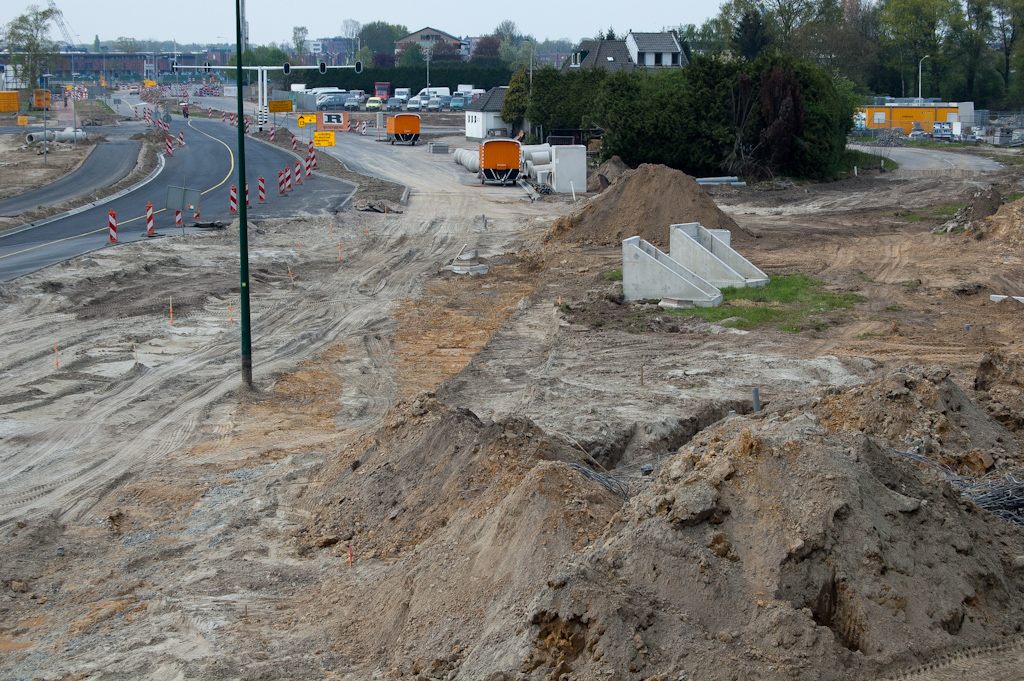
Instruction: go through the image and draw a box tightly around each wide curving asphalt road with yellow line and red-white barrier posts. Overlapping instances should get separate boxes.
[0,118,355,281]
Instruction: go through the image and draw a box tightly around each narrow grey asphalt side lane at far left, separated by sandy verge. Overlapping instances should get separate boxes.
[0,139,142,217]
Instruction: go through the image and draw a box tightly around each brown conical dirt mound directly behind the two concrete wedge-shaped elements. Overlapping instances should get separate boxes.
[549,164,750,249]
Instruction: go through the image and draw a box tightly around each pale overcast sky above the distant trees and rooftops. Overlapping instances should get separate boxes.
[0,0,721,44]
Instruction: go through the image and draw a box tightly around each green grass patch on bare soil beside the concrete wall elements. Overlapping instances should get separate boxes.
[668,274,864,333]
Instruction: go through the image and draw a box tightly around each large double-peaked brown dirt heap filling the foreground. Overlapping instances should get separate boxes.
[299,372,1024,681]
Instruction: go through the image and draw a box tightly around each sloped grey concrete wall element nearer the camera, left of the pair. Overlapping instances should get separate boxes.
[623,237,722,307]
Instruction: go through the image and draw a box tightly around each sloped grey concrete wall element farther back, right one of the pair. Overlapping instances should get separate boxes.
[669,222,768,288]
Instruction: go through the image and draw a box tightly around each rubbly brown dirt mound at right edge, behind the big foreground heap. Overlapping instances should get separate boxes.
[814,363,1021,475]
